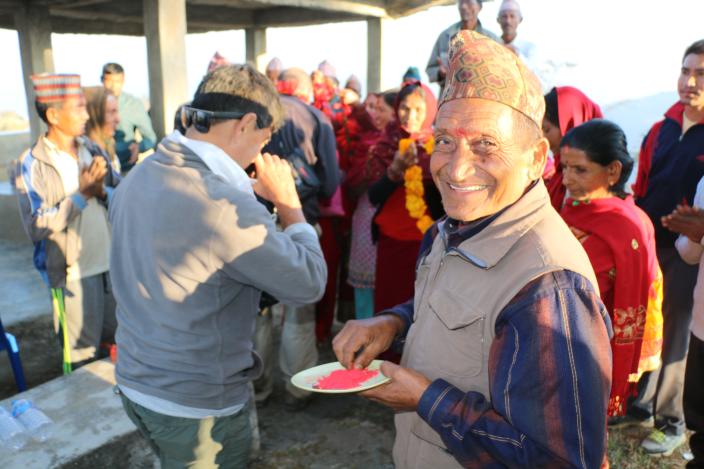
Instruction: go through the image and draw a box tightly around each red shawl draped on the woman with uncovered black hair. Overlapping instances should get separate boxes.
[561,196,660,415]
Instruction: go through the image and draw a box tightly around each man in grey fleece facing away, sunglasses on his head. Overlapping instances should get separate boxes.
[110,65,326,468]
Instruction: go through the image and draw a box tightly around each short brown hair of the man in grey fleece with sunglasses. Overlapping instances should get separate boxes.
[191,64,285,130]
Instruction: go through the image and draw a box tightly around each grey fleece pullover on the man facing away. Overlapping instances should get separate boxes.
[110,139,327,409]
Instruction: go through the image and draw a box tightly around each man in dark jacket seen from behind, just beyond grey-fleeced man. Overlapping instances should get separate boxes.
[255,68,340,409]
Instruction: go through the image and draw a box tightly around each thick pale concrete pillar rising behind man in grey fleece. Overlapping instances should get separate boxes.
[143,0,188,139]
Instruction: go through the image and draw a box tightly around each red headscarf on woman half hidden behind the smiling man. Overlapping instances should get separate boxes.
[546,86,604,212]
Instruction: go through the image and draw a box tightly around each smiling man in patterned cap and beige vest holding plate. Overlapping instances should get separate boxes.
[334,31,611,468]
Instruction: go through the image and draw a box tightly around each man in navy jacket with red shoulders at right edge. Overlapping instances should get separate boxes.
[619,41,704,454]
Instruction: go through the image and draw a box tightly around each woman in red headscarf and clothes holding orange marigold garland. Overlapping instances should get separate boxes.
[368,81,442,311]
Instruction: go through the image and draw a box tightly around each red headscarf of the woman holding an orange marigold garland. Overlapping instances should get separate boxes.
[367,81,438,182]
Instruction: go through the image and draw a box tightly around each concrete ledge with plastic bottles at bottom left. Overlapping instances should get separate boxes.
[0,360,144,469]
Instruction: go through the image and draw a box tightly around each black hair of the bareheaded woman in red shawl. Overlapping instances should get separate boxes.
[560,119,633,198]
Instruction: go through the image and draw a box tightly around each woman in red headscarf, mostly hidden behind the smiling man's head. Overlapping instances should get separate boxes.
[543,86,604,208]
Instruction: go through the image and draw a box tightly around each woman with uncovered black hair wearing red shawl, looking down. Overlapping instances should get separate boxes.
[560,119,662,417]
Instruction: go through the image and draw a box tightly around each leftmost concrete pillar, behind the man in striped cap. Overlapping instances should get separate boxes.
[15,2,54,142]
